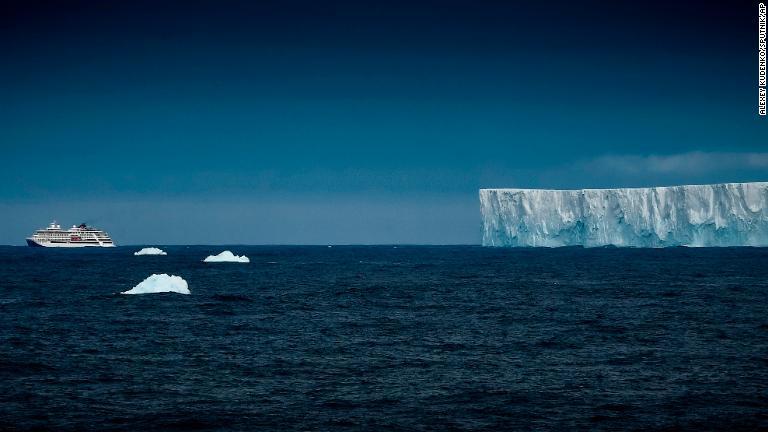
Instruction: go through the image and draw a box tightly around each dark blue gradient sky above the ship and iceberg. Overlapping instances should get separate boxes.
[0,1,768,244]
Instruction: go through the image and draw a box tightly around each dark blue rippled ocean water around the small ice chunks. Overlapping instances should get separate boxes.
[0,246,768,431]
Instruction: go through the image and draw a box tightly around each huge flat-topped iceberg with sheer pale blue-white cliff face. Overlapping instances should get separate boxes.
[480,183,768,247]
